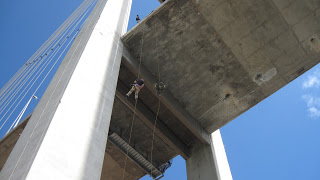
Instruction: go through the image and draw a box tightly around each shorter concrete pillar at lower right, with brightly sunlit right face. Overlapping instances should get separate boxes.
[186,130,232,180]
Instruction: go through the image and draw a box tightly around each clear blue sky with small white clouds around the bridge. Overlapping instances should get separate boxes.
[0,0,320,180]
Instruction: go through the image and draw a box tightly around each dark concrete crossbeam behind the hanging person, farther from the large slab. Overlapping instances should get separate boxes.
[116,80,190,159]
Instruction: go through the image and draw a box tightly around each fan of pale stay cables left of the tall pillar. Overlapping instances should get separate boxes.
[0,0,96,136]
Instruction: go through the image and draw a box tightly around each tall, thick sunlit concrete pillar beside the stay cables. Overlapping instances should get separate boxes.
[0,0,131,180]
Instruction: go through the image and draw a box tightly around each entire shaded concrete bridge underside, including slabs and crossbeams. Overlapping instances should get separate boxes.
[0,0,320,179]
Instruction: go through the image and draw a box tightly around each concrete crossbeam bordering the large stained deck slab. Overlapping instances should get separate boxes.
[122,47,210,144]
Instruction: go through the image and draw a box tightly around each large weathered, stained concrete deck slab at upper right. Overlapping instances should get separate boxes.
[122,0,320,133]
